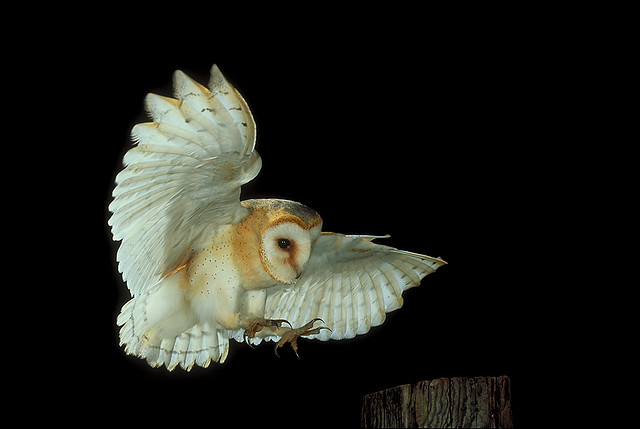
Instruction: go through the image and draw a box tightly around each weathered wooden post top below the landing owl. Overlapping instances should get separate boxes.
[361,376,513,428]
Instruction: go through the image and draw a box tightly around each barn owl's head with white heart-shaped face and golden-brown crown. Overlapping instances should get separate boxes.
[242,199,322,284]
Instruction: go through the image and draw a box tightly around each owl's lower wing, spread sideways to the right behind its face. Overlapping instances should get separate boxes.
[265,233,446,340]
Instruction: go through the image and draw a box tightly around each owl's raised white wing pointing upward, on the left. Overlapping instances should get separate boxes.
[109,65,262,296]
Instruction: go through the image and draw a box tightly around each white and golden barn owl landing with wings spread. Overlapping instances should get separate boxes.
[108,65,446,370]
